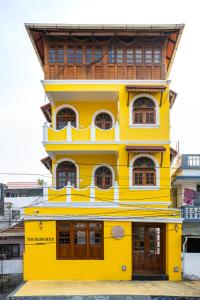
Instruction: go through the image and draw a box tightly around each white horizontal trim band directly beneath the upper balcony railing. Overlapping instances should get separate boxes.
[43,140,171,145]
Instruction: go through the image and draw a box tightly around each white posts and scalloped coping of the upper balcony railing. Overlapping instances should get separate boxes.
[43,121,120,143]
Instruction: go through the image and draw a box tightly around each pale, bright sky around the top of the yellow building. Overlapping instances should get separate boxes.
[0,0,200,183]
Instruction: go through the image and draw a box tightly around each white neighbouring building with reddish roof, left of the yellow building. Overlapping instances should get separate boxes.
[0,182,43,230]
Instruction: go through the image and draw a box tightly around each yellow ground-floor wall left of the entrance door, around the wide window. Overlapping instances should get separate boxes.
[24,221,132,280]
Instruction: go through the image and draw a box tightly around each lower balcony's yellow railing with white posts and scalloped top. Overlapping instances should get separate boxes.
[43,182,119,204]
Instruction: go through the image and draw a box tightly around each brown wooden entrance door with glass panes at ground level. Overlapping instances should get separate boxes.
[133,223,165,274]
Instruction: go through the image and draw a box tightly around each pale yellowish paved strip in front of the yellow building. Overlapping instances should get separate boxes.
[14,280,200,297]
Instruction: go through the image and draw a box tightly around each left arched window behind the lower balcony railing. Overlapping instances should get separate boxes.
[56,161,76,189]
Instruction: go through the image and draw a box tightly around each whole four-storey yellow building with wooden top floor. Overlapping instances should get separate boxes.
[24,24,184,280]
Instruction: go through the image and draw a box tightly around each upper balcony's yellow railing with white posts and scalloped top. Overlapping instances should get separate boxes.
[43,122,120,143]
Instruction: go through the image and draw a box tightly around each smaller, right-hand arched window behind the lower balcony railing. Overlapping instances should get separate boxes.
[94,166,112,189]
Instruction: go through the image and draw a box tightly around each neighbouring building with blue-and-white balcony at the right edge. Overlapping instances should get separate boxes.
[172,154,200,279]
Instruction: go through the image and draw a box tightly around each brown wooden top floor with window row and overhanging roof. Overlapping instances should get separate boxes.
[25,24,184,80]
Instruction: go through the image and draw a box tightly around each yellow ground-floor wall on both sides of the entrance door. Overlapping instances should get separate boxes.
[24,217,181,280]
